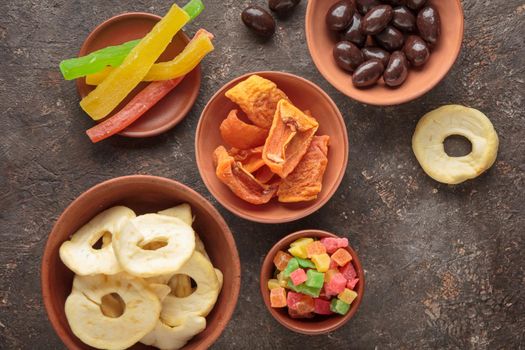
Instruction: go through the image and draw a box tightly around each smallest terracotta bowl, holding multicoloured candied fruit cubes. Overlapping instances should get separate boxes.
[260,230,365,335]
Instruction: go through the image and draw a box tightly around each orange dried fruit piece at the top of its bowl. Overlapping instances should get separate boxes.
[225,75,288,129]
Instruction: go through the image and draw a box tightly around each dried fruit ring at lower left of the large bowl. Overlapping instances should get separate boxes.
[65,273,161,349]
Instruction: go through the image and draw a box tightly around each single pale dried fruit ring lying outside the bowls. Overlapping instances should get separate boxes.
[412,105,499,184]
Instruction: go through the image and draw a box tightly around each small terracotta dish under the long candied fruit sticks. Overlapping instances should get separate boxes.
[77,12,201,137]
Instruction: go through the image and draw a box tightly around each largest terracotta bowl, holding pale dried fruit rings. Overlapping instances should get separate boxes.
[41,175,241,350]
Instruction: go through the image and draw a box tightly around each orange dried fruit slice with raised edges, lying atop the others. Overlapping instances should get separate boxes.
[263,100,319,179]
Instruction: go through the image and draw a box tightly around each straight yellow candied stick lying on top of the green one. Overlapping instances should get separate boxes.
[80,4,190,120]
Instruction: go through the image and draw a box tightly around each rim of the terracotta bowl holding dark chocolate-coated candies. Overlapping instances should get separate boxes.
[305,0,465,106]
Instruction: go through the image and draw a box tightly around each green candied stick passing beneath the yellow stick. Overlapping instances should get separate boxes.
[59,0,204,80]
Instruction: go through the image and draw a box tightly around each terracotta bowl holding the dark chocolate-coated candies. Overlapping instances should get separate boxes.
[306,0,464,106]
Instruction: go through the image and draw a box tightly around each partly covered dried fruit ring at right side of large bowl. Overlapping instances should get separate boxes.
[160,252,221,326]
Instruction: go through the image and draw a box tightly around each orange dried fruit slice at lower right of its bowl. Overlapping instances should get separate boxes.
[277,136,330,203]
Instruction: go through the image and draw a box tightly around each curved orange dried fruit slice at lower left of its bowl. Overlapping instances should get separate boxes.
[213,146,277,204]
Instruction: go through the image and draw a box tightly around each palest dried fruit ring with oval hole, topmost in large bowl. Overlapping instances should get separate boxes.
[113,214,195,277]
